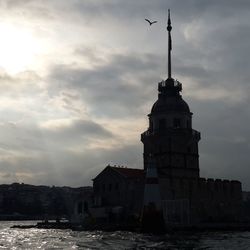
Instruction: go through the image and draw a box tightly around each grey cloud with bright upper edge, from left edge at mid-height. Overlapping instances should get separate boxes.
[0,119,115,153]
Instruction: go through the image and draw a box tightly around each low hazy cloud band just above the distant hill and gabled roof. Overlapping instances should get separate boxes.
[0,136,142,187]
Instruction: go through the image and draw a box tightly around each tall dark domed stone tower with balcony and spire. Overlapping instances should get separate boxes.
[141,9,200,178]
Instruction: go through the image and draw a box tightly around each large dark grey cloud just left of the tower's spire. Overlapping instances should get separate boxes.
[49,51,160,117]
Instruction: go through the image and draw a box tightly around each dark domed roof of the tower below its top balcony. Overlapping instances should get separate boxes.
[151,96,190,114]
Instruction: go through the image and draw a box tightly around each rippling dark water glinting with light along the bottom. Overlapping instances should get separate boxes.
[0,222,250,250]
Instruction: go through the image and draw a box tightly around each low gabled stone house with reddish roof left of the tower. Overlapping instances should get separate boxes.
[93,165,145,216]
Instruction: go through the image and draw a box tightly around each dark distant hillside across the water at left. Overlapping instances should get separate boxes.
[0,183,92,220]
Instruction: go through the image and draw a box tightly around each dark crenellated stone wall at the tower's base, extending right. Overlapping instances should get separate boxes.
[159,178,242,223]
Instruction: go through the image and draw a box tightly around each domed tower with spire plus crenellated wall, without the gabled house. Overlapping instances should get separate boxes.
[141,9,242,224]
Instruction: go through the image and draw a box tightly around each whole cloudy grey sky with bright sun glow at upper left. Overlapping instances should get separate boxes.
[0,0,250,190]
